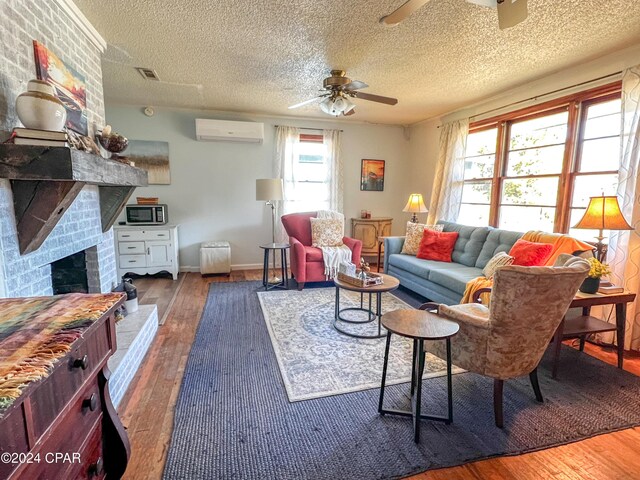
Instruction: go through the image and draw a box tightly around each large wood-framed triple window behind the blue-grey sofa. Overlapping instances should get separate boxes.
[458,83,621,240]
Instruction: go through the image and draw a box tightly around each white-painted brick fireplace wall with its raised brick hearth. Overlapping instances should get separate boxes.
[0,0,158,406]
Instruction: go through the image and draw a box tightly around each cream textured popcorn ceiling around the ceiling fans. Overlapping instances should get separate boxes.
[75,0,640,124]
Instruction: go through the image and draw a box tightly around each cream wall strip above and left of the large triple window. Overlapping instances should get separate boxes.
[409,45,640,207]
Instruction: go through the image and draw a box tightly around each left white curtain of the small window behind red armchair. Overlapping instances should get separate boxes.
[274,125,300,243]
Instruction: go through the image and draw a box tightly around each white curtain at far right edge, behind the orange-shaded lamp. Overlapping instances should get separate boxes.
[600,65,640,350]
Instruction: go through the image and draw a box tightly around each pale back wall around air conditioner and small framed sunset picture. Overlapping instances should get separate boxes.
[106,104,411,268]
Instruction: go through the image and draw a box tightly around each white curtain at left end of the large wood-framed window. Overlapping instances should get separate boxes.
[427,119,469,224]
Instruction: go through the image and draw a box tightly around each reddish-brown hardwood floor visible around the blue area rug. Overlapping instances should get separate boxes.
[119,270,640,480]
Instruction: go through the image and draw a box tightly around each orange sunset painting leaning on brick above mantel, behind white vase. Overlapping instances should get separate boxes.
[33,40,89,137]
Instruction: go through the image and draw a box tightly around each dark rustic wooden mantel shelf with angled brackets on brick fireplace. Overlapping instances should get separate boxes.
[0,144,148,254]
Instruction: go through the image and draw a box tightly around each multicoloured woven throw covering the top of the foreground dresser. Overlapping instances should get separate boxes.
[0,293,123,417]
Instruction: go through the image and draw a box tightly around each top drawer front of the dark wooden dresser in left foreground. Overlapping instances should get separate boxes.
[31,322,110,438]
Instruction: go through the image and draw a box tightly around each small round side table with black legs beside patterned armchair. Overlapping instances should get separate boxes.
[378,309,460,443]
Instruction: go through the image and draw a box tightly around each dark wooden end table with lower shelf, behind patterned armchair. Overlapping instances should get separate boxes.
[552,292,636,378]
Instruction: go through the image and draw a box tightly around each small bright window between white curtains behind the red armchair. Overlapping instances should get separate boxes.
[291,135,329,212]
